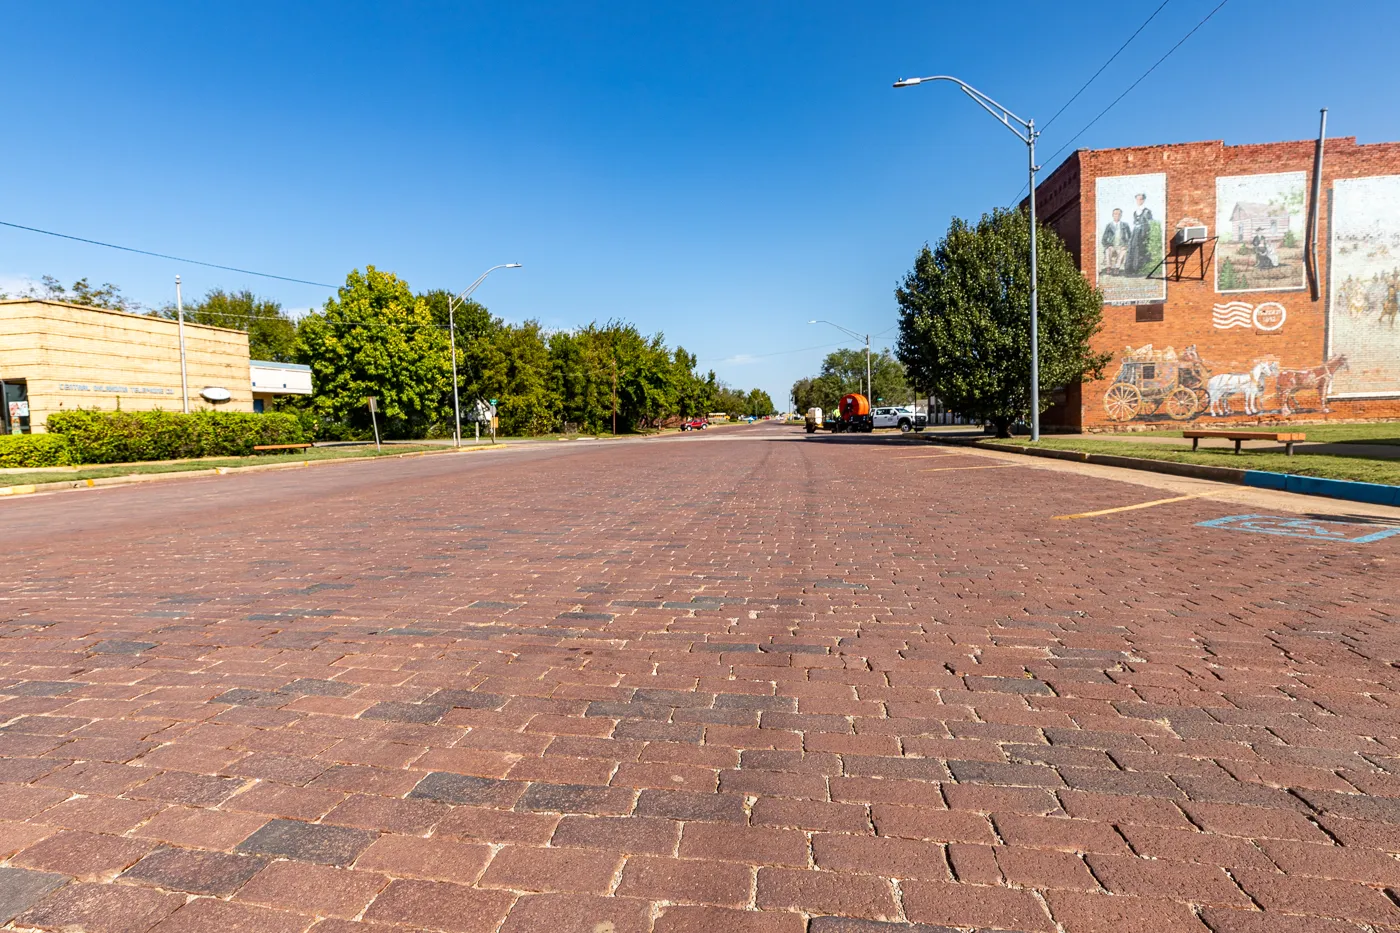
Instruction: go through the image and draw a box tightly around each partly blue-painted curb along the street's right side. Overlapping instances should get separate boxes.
[928,437,1400,506]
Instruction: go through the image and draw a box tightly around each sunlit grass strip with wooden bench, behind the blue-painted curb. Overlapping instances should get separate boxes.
[983,437,1400,486]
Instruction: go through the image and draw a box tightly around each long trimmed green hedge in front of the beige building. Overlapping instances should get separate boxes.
[48,409,304,464]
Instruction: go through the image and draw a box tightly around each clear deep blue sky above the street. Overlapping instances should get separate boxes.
[0,0,1400,406]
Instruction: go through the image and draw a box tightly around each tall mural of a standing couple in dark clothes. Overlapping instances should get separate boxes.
[1093,174,1166,304]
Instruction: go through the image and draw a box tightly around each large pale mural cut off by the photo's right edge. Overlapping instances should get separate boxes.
[1327,175,1400,396]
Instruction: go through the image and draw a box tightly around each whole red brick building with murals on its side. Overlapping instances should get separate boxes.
[1036,137,1400,430]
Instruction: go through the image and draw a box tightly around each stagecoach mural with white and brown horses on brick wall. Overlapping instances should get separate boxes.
[1103,343,1350,424]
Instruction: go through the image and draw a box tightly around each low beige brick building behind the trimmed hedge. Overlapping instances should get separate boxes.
[0,298,253,433]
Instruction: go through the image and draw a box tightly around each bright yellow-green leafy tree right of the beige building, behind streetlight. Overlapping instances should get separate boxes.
[297,266,452,437]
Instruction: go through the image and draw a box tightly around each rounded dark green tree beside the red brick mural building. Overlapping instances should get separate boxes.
[895,210,1112,437]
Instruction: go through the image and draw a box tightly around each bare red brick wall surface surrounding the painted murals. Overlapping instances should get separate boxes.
[1036,137,1400,430]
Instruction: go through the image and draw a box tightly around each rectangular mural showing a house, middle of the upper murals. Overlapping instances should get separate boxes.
[1215,172,1308,291]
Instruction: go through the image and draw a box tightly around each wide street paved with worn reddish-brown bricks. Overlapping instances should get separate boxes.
[0,427,1400,933]
